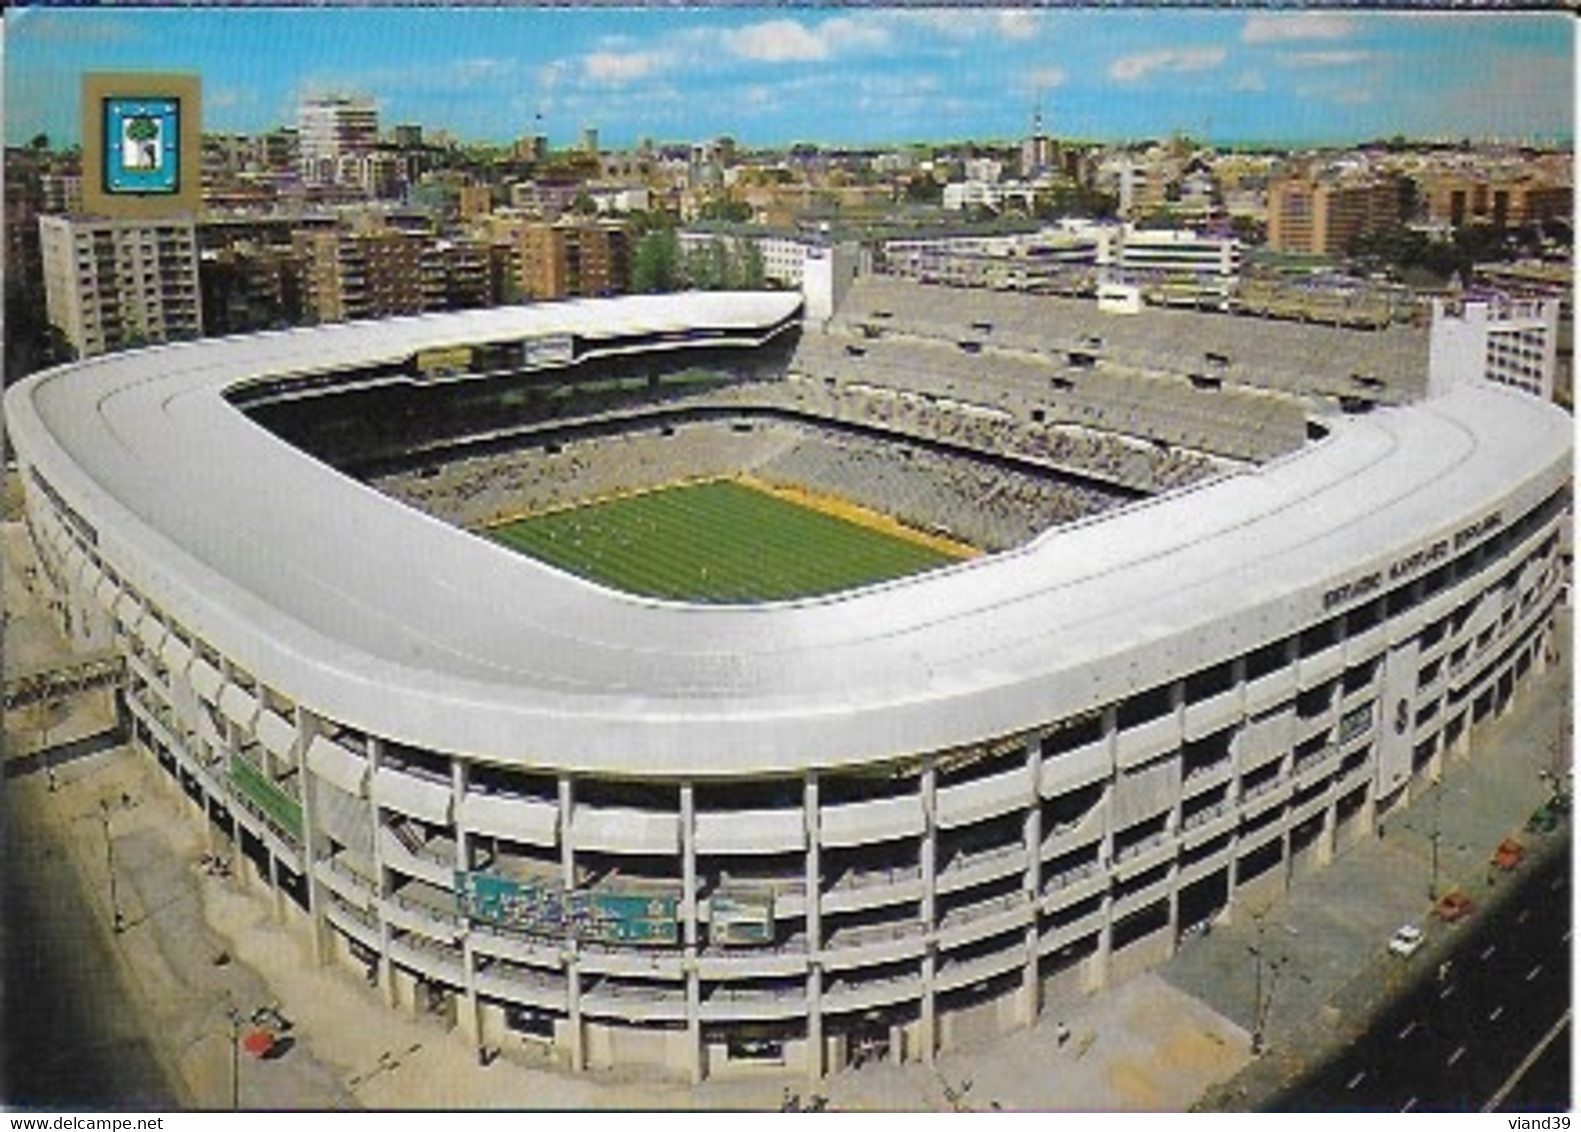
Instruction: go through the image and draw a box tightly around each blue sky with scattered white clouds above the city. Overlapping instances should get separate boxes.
[3,3,1576,149]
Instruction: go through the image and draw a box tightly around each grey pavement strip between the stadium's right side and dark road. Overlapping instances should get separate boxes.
[1188,610,1572,1111]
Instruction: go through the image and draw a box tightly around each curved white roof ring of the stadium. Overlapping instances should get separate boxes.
[5,296,1572,776]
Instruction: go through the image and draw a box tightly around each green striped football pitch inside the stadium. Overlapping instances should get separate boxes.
[484,481,955,602]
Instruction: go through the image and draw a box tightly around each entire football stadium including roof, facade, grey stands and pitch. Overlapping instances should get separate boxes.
[5,277,1572,1081]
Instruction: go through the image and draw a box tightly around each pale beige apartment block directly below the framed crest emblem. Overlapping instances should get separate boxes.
[38,215,202,357]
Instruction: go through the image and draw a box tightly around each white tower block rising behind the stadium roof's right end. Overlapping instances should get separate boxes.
[1428,294,1559,400]
